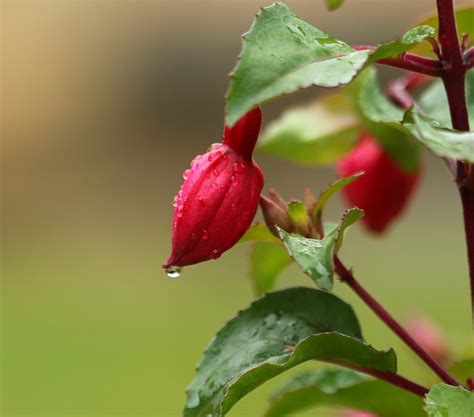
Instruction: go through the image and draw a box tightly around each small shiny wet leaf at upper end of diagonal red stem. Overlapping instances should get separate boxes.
[278,208,364,291]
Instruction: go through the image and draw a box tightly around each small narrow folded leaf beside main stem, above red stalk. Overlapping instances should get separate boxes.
[368,25,436,63]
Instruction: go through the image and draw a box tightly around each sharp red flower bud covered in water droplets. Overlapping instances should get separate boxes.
[163,108,263,269]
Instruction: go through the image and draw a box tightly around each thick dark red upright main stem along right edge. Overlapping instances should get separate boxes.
[436,0,474,320]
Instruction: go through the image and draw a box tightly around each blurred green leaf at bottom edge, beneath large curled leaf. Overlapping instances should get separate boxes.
[265,369,426,417]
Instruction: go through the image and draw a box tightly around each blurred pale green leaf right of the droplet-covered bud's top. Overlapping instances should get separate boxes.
[258,94,359,165]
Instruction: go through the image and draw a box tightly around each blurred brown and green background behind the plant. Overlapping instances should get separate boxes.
[0,0,471,417]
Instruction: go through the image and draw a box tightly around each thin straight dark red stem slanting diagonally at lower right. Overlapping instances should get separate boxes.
[334,255,460,386]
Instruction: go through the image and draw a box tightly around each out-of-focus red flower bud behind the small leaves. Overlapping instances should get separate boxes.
[337,133,419,233]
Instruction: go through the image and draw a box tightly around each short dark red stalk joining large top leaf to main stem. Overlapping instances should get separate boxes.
[352,45,443,77]
